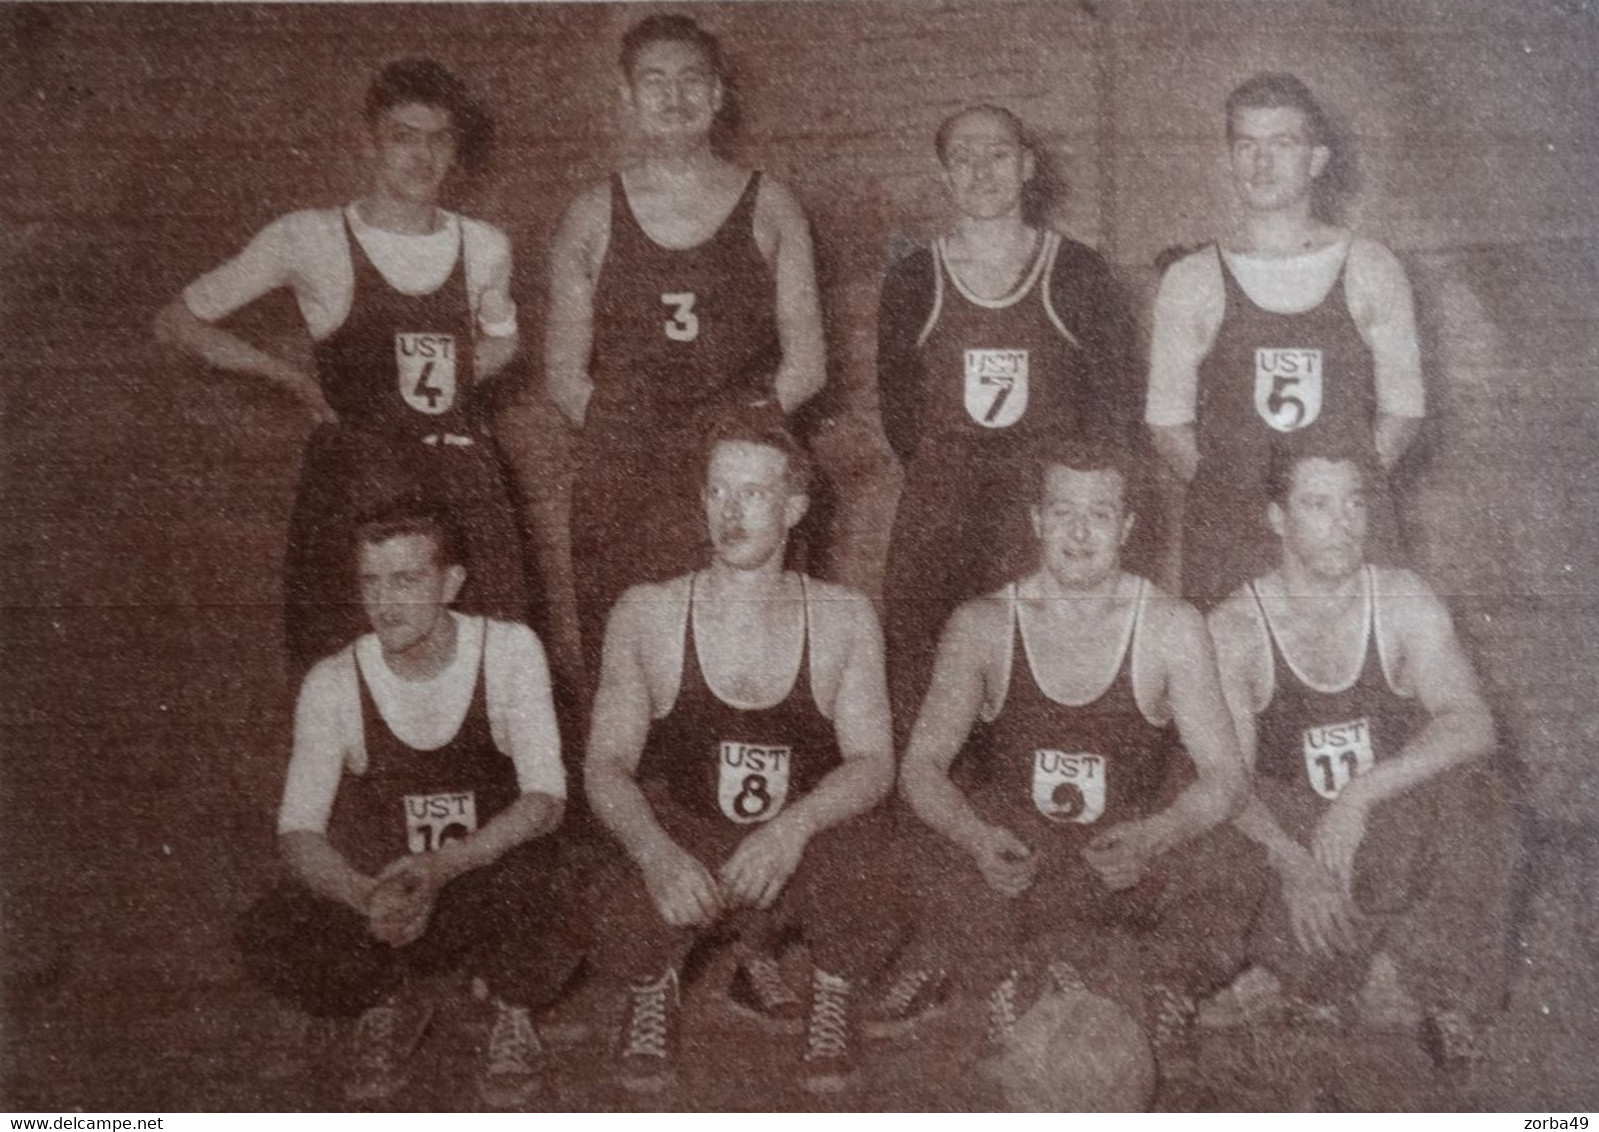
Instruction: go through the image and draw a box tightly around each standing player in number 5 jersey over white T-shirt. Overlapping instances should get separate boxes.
[1145,74,1425,609]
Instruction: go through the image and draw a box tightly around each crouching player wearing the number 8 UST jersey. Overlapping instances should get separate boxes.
[587,411,894,1090]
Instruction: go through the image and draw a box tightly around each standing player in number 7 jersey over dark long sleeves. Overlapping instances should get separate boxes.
[878,106,1137,731]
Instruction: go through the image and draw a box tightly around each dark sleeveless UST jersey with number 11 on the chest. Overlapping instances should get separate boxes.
[1249,566,1428,807]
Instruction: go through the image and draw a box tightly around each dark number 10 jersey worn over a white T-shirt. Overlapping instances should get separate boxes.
[328,624,521,875]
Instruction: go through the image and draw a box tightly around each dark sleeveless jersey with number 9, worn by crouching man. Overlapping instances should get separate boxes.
[971,579,1178,831]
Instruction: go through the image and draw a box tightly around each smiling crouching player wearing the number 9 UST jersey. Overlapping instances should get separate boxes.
[900,444,1263,1106]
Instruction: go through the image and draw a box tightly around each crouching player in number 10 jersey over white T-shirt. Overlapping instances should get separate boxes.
[240,510,577,1108]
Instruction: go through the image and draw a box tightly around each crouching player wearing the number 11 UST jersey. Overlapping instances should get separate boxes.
[1207,449,1509,1062]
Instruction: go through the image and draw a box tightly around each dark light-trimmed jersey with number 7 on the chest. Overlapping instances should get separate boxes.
[918,232,1086,454]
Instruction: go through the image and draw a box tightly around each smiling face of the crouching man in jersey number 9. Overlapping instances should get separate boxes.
[1033,464,1132,590]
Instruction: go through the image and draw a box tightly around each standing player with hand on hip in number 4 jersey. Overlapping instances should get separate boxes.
[157,59,528,676]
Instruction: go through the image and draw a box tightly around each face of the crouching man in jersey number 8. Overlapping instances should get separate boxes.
[702,440,806,569]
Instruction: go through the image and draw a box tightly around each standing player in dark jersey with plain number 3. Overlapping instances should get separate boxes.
[545,16,825,676]
